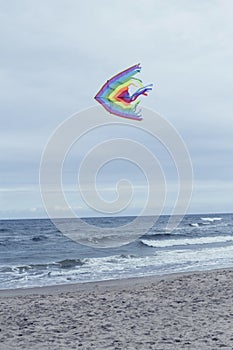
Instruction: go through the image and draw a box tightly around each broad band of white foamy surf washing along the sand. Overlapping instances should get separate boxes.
[1,243,233,288]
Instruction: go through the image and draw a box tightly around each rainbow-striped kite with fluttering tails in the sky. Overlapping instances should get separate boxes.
[95,64,153,120]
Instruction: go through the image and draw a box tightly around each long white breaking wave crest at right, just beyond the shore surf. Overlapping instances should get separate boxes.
[141,236,233,248]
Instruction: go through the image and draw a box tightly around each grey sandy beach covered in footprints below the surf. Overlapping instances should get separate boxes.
[0,269,233,350]
